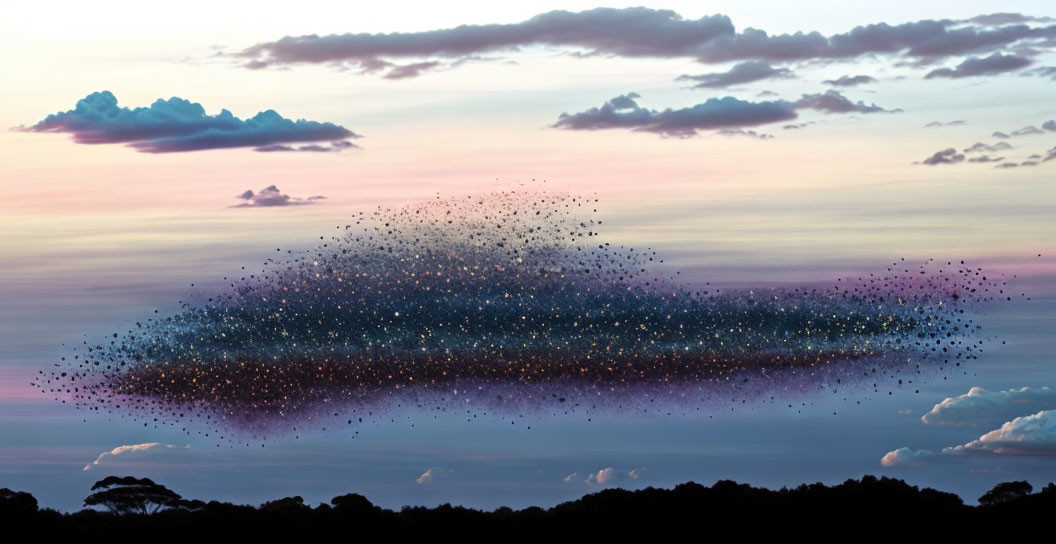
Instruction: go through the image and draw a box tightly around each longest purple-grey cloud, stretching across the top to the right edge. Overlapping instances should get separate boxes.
[234,7,1056,75]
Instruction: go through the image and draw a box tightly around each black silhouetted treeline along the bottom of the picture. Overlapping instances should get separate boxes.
[0,476,1056,540]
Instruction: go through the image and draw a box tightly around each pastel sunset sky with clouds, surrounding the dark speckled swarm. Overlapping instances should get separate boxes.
[0,1,1056,509]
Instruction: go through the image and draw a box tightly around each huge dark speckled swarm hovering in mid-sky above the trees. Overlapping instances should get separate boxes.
[34,190,1012,437]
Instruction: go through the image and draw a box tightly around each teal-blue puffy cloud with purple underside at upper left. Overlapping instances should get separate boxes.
[20,91,359,153]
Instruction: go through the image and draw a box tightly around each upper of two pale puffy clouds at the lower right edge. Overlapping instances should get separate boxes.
[921,387,1056,426]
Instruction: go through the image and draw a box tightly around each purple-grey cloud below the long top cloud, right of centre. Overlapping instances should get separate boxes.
[551,90,900,137]
